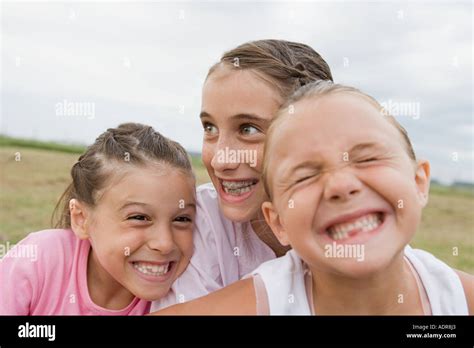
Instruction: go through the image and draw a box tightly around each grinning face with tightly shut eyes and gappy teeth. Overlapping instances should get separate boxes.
[263,93,429,278]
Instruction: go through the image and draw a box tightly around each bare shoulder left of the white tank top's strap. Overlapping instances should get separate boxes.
[151,278,257,315]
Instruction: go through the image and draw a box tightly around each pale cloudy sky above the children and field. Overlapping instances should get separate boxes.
[0,1,474,183]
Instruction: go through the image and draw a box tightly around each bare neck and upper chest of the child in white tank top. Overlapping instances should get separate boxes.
[311,252,423,315]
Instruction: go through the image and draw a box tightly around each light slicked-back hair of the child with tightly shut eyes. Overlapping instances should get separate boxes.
[262,81,416,199]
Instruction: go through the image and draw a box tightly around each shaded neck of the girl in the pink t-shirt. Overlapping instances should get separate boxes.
[87,246,135,310]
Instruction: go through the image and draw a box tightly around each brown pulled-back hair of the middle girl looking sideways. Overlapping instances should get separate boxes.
[206,40,332,99]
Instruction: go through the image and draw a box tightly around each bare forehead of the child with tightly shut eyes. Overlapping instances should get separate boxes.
[267,95,402,162]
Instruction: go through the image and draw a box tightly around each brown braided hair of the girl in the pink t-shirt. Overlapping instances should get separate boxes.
[51,123,194,228]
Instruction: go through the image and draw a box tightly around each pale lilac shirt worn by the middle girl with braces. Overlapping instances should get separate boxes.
[152,183,276,311]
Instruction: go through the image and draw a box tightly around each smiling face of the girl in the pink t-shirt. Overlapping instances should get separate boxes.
[71,164,196,300]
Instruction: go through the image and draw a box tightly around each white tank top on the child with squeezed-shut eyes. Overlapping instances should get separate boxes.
[251,246,469,315]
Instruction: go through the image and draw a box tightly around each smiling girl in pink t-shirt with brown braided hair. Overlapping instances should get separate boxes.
[0,123,196,315]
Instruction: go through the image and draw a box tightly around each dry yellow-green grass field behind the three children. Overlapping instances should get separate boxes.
[0,137,474,273]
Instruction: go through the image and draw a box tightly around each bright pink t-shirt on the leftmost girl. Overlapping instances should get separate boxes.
[0,229,150,315]
